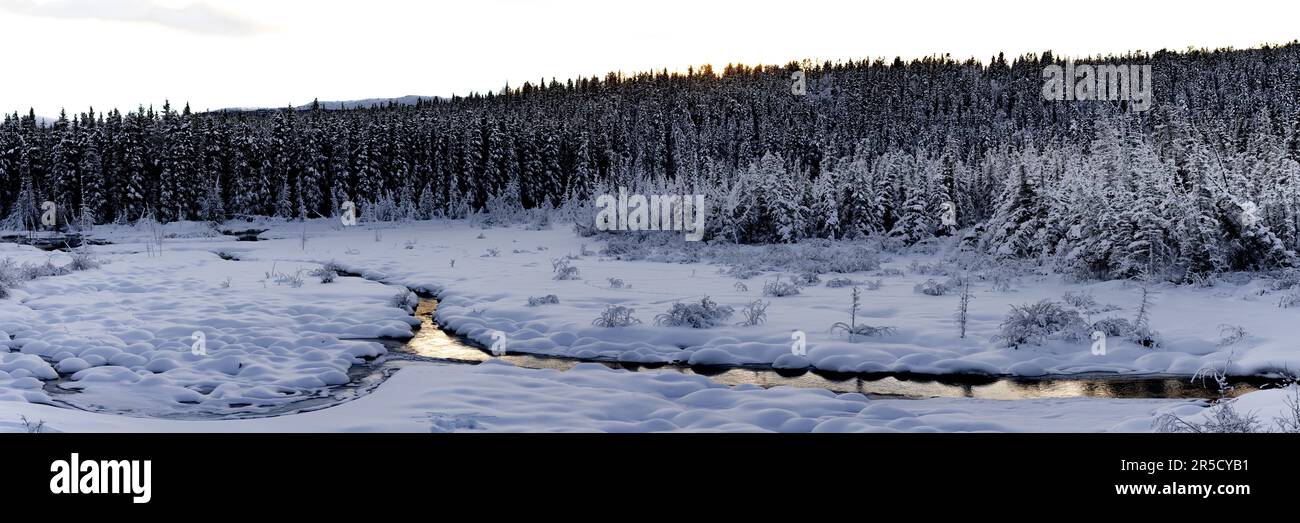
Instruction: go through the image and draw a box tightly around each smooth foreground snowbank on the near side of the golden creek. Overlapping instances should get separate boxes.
[0,360,1201,432]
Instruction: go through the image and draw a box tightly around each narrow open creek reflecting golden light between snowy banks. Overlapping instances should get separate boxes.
[395,298,1266,399]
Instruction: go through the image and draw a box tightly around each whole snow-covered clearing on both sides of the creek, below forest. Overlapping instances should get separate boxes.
[0,220,1300,432]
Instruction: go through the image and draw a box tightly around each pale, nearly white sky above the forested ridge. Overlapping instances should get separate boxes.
[0,0,1300,116]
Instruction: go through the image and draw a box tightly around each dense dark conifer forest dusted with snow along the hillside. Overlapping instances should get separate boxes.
[0,43,1300,278]
